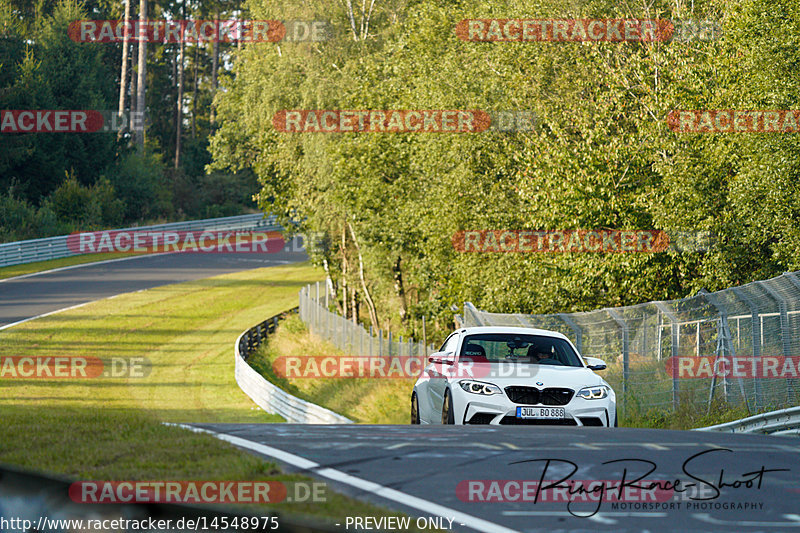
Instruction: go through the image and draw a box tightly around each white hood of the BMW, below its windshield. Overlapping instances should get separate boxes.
[451,363,606,389]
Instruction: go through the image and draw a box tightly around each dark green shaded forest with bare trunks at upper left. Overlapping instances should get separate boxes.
[0,0,258,242]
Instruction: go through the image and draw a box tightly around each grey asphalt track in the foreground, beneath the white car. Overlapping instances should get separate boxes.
[194,424,800,533]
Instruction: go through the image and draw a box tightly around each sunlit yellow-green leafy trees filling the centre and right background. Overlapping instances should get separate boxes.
[211,0,800,333]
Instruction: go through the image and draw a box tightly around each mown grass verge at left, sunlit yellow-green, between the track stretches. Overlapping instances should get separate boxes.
[0,265,406,518]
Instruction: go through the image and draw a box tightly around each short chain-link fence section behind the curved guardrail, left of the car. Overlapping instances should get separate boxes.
[300,282,436,359]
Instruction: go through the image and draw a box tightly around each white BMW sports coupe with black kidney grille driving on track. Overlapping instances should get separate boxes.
[411,327,617,427]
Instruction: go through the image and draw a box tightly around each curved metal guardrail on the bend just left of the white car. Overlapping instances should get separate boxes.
[235,308,353,424]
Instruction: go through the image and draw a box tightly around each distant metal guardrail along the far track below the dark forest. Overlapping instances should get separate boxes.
[0,213,283,267]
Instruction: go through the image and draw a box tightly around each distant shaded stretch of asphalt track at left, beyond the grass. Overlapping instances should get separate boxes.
[0,251,308,328]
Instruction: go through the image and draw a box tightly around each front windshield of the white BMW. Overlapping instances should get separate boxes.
[459,333,583,367]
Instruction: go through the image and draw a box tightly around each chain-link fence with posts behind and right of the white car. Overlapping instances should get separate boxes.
[458,273,800,412]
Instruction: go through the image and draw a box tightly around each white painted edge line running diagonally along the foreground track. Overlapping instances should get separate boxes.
[177,424,518,533]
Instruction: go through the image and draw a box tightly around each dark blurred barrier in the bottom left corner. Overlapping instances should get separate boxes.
[0,466,342,533]
